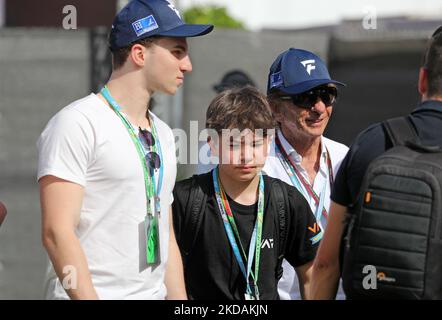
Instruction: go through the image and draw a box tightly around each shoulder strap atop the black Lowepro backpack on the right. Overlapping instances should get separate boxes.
[382,116,418,146]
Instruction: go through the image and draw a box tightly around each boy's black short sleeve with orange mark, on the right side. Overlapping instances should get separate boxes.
[285,186,322,268]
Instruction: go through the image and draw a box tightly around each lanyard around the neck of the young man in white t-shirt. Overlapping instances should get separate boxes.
[100,86,163,215]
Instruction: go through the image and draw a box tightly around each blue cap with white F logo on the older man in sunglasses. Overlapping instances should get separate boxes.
[267,48,345,94]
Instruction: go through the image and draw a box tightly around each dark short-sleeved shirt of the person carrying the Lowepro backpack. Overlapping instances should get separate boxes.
[331,100,442,206]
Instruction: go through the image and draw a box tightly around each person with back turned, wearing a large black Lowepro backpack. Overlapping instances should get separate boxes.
[310,26,442,299]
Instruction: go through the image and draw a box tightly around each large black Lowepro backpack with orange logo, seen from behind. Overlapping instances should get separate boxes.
[342,117,442,299]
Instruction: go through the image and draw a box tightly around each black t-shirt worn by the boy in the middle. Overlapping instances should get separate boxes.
[172,172,319,300]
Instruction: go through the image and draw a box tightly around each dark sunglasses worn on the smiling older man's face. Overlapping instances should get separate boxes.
[279,87,338,109]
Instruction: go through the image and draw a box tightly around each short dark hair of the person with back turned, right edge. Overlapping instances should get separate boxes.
[423,27,442,97]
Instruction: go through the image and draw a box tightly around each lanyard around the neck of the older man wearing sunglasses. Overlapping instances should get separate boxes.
[275,134,333,221]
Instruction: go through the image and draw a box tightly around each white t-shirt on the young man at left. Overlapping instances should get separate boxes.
[37,94,176,299]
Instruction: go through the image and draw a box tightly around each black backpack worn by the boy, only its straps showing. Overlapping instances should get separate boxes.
[175,175,289,296]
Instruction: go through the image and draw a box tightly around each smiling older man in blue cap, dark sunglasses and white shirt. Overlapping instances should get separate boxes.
[263,48,348,300]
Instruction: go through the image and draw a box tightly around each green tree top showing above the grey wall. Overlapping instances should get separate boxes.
[184,6,245,29]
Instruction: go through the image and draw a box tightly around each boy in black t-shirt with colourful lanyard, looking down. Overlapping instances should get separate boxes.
[172,86,322,300]
